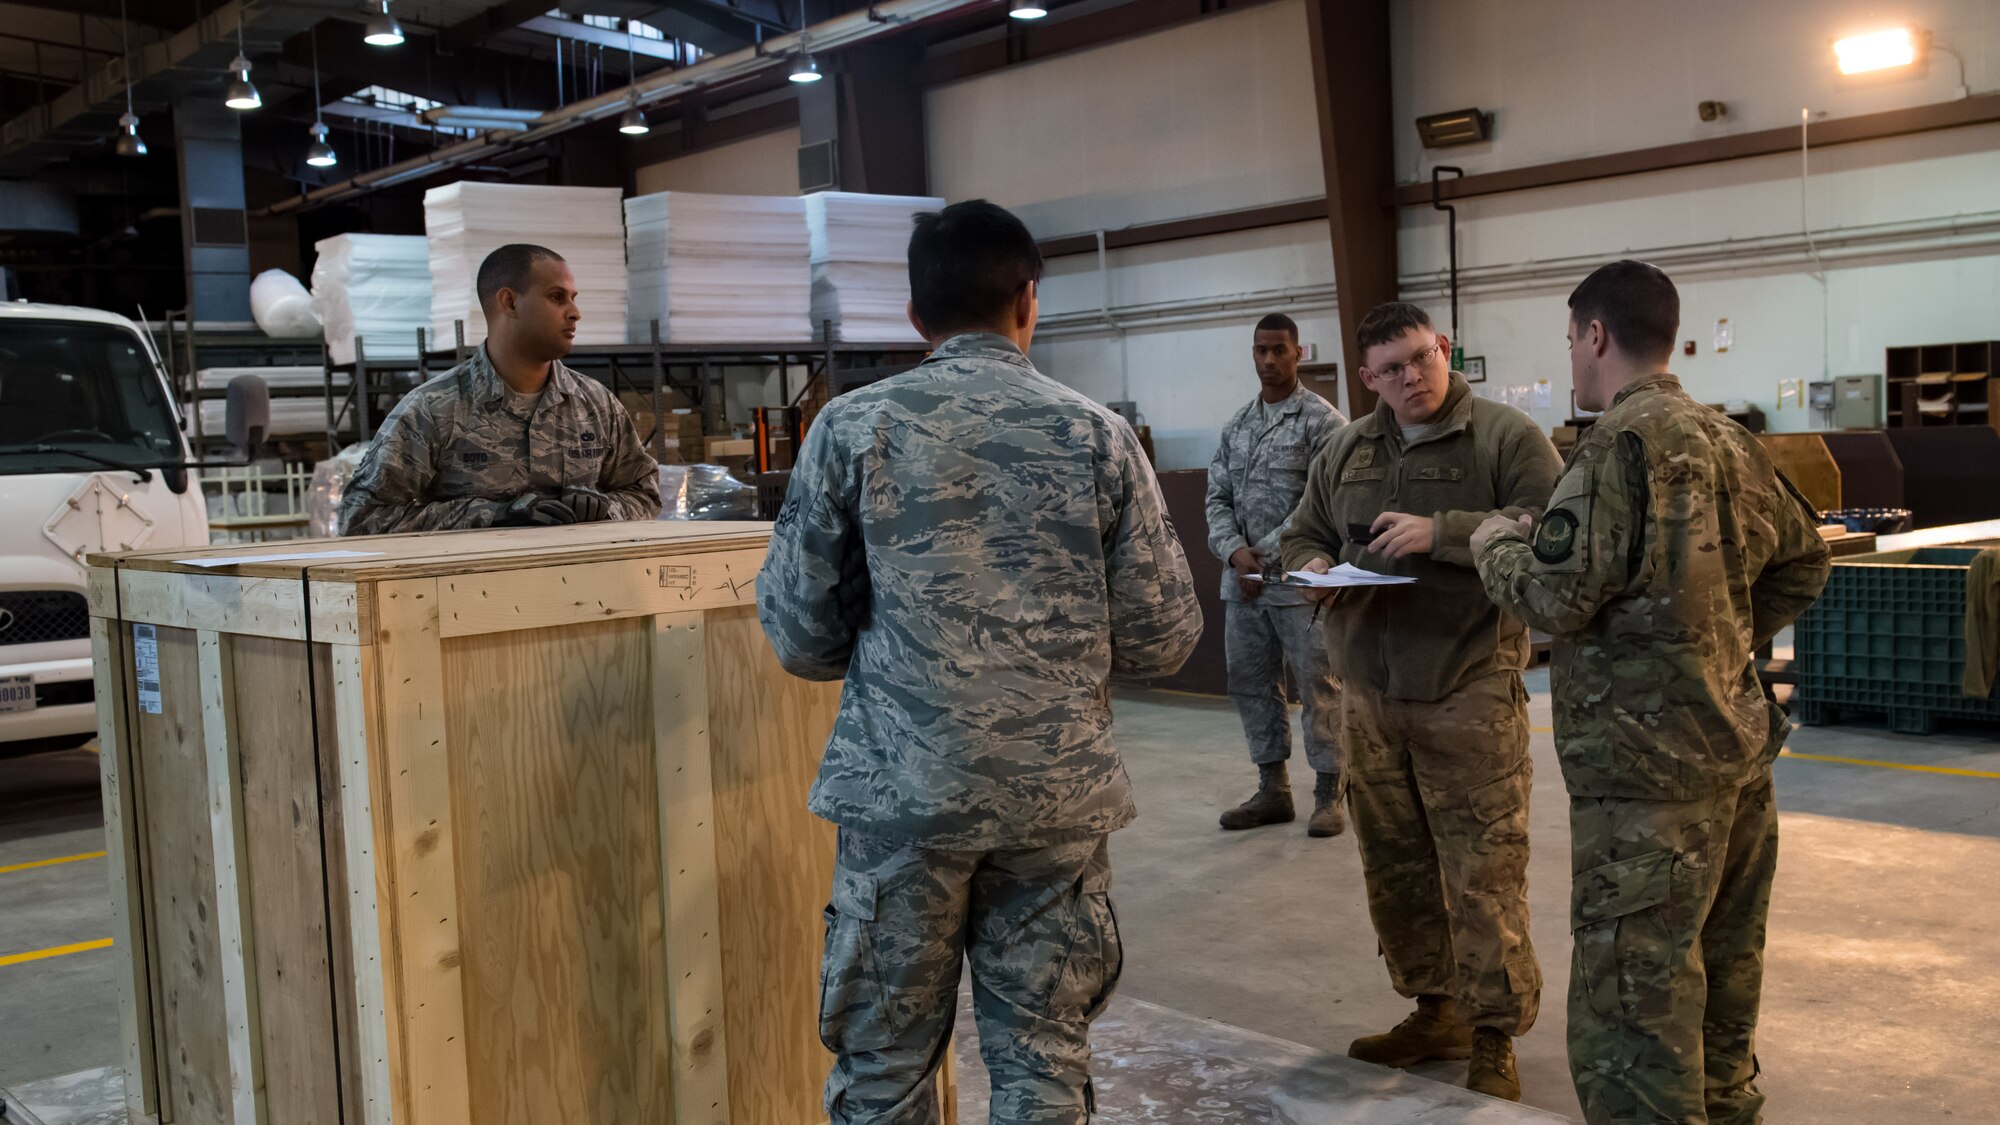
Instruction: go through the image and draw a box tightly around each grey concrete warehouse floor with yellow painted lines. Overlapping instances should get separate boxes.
[0,673,2000,1125]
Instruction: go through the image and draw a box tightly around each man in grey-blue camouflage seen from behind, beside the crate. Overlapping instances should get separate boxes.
[758,200,1202,1125]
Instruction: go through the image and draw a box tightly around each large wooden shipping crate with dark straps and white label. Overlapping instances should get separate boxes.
[90,522,952,1125]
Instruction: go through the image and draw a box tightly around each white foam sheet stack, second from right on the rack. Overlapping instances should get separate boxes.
[624,192,812,344]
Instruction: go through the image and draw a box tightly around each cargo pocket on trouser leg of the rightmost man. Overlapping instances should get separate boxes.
[1570,849,1686,1019]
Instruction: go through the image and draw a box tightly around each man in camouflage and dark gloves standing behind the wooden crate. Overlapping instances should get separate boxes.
[340,244,660,534]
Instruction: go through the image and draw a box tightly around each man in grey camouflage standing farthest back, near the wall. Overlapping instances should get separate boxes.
[1208,312,1348,837]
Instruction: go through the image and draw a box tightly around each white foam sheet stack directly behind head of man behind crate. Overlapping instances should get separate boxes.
[424,182,626,348]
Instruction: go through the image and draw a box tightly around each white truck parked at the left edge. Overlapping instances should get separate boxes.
[0,302,268,757]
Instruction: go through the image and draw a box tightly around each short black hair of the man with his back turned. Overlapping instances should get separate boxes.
[910,200,1042,334]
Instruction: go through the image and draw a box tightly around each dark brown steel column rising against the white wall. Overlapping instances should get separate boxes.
[1306,0,1398,416]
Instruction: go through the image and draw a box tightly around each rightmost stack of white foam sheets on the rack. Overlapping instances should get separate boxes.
[806,192,944,342]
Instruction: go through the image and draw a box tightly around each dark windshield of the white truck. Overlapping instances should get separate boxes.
[0,318,182,474]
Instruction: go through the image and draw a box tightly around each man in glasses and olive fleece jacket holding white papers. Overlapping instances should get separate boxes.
[1280,302,1562,1101]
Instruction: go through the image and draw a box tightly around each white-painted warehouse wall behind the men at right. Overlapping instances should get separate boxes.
[926,0,2000,466]
